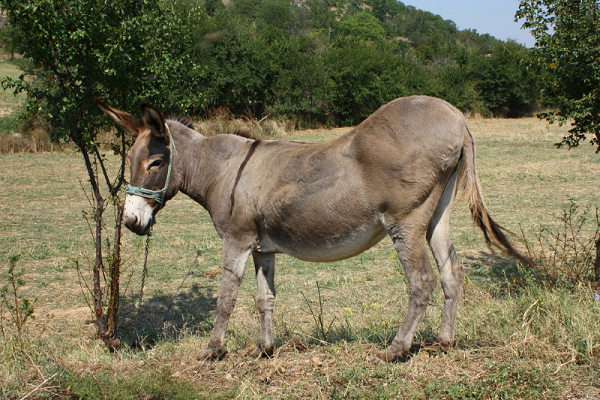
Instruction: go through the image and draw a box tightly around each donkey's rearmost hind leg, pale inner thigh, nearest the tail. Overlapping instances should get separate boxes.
[427,172,464,350]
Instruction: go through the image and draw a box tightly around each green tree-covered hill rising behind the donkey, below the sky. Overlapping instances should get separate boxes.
[189,0,540,125]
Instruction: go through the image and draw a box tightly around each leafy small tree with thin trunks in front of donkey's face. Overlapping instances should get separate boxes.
[0,0,158,348]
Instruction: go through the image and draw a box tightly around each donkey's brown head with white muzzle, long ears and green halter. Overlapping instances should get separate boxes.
[97,102,176,235]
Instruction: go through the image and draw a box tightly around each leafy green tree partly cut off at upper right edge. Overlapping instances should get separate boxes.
[516,0,600,152]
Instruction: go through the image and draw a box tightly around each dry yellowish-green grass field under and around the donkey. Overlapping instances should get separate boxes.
[0,119,600,399]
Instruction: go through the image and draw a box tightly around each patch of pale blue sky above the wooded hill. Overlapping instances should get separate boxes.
[400,0,535,47]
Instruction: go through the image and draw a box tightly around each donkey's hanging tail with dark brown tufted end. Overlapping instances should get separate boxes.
[459,122,531,265]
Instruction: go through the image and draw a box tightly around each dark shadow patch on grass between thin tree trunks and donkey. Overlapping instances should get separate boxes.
[119,284,217,349]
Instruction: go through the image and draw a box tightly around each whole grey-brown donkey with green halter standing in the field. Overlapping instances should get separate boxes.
[99,96,527,361]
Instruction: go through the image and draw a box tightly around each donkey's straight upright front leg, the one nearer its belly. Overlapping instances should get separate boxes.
[251,252,275,357]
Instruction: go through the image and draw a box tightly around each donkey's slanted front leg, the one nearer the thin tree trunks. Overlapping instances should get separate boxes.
[198,241,251,360]
